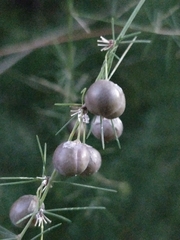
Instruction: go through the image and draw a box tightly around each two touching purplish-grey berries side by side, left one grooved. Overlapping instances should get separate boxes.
[53,140,101,176]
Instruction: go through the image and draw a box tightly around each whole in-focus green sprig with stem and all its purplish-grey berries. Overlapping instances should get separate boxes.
[2,0,148,236]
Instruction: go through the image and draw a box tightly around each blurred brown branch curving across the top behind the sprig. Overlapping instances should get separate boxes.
[0,21,180,56]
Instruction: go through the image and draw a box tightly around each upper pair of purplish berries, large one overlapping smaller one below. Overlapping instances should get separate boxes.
[85,80,126,142]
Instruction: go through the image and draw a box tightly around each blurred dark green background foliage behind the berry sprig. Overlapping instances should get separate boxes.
[0,0,180,240]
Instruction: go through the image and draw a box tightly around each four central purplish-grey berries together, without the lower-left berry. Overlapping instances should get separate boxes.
[53,80,126,176]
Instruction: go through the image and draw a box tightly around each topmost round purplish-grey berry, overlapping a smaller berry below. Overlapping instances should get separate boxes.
[85,80,126,119]
